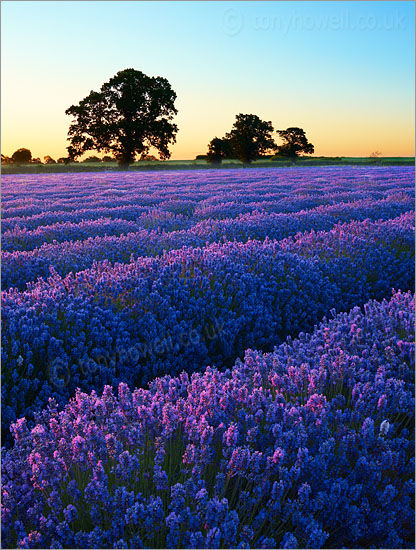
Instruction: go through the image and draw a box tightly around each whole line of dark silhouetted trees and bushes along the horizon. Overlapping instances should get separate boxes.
[1,69,314,167]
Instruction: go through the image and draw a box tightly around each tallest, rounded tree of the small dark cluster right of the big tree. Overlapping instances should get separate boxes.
[225,113,276,163]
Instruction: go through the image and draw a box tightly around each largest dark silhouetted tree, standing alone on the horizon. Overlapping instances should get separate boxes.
[65,69,178,167]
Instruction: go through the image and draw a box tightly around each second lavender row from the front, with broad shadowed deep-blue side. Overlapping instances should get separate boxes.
[2,215,414,444]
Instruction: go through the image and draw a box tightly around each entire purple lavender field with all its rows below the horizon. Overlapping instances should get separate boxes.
[1,166,415,548]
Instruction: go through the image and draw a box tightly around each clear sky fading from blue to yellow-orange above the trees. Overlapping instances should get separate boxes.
[1,0,415,160]
